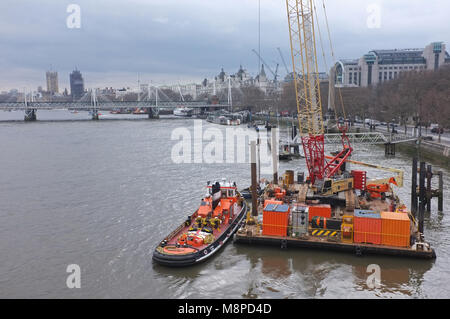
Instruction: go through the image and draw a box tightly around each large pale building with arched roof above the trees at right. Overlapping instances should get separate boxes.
[332,42,450,87]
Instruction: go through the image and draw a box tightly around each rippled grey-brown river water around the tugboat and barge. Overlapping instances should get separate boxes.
[0,111,450,298]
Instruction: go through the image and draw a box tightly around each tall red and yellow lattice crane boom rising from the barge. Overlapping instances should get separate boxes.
[286,0,353,189]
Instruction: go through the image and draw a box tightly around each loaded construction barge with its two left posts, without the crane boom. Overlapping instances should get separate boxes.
[234,134,436,259]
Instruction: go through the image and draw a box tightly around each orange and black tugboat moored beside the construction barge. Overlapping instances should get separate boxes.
[153,179,247,267]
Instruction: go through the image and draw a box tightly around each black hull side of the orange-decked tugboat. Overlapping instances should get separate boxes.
[152,201,248,267]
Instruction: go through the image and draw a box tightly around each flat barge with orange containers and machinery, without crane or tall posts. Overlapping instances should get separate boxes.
[235,171,436,259]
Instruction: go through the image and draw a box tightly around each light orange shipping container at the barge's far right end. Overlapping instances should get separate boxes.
[381,212,411,247]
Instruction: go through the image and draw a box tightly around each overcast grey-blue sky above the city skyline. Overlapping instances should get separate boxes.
[0,0,450,90]
